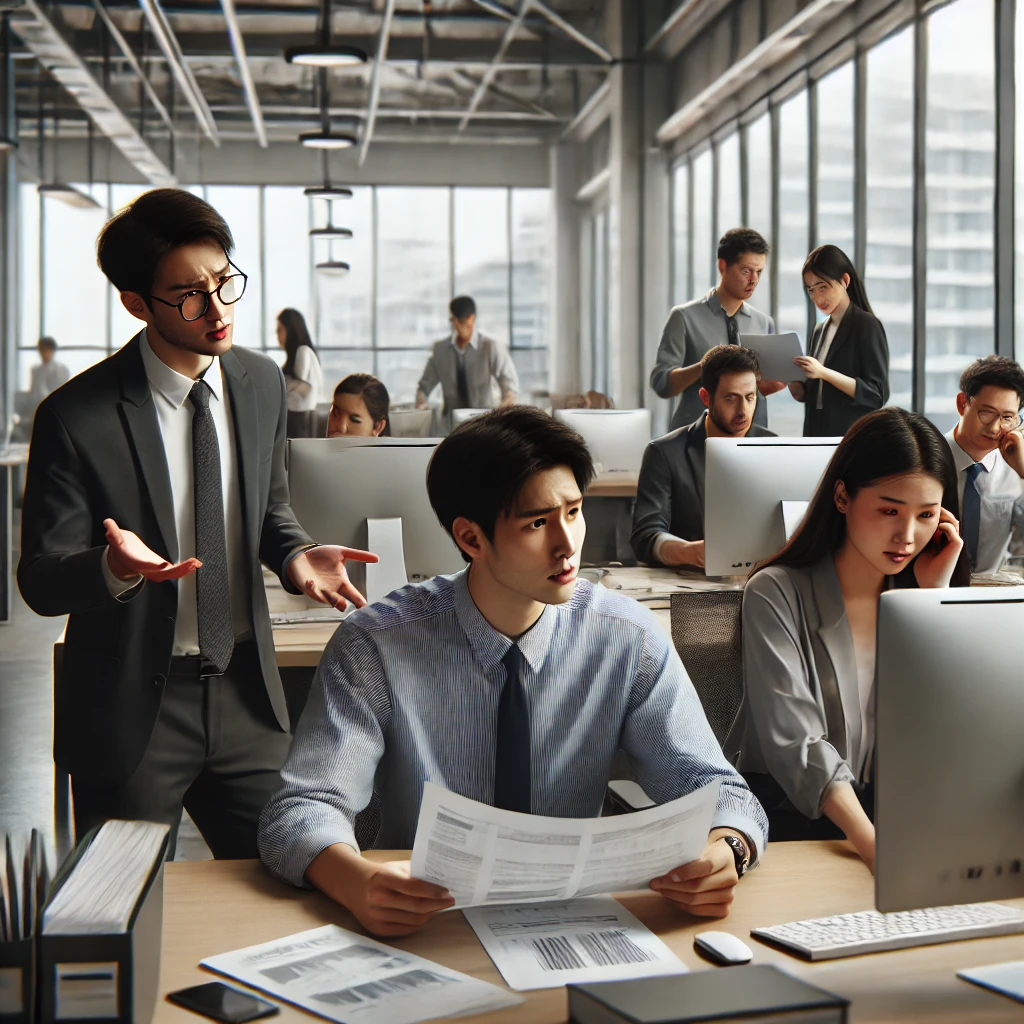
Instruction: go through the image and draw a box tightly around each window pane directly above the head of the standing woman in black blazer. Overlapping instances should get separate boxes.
[814,62,854,252]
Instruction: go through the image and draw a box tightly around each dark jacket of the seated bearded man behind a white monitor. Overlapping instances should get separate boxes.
[630,413,775,565]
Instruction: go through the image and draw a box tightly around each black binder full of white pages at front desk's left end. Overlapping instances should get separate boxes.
[38,826,169,1024]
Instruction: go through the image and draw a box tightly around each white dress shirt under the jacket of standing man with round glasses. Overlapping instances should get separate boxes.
[102,330,252,657]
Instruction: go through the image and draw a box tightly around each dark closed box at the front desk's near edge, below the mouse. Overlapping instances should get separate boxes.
[568,965,850,1024]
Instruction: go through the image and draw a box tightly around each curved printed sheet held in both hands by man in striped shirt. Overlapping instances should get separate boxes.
[412,779,721,907]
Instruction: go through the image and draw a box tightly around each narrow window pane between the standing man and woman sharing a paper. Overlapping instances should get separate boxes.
[768,92,810,434]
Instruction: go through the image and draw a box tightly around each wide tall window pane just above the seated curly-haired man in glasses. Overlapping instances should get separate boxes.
[925,0,995,429]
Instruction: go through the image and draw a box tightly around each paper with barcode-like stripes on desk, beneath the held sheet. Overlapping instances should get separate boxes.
[463,896,686,991]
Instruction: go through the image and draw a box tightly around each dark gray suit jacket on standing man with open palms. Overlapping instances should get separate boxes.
[17,336,312,784]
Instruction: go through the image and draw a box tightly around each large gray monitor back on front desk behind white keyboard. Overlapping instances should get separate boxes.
[874,587,1024,911]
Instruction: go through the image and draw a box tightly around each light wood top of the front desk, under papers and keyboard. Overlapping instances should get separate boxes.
[155,843,1024,1024]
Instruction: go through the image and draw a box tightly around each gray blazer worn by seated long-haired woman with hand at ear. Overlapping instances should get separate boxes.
[724,555,864,818]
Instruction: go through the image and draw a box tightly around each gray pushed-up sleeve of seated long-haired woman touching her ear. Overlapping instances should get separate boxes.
[742,572,856,818]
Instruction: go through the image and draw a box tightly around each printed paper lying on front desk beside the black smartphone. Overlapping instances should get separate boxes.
[202,925,522,1024]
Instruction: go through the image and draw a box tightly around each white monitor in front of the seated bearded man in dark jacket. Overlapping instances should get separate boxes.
[703,437,842,575]
